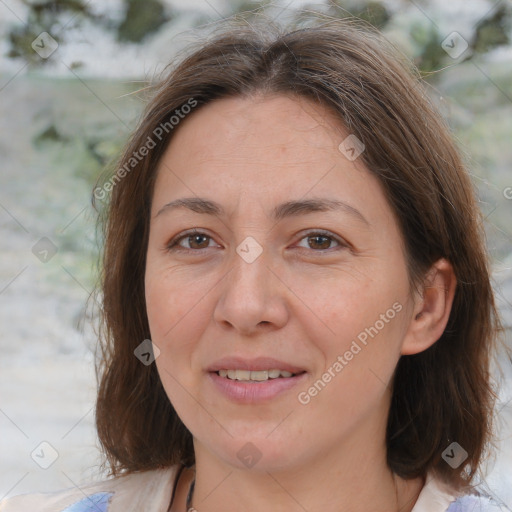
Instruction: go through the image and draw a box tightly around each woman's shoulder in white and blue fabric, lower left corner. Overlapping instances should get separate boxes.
[0,465,180,512]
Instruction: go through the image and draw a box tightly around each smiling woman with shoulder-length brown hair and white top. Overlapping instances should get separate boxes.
[0,16,505,512]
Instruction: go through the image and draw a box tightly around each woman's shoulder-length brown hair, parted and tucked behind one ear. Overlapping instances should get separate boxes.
[91,14,501,489]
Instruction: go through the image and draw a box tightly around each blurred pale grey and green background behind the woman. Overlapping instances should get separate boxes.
[0,0,512,508]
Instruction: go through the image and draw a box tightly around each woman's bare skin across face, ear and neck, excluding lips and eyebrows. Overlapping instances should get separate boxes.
[145,95,456,512]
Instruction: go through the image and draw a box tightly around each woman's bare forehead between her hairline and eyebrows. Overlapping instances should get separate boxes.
[153,95,389,227]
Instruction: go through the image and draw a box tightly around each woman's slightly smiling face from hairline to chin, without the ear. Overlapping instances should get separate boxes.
[145,95,420,471]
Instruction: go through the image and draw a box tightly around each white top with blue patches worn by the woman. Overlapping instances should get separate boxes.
[0,465,510,512]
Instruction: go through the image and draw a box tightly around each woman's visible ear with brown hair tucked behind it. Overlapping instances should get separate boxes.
[401,258,457,355]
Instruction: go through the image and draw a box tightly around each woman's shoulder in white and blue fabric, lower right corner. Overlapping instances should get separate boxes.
[412,474,511,512]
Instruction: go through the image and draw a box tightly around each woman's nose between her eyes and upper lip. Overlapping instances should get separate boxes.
[214,244,290,336]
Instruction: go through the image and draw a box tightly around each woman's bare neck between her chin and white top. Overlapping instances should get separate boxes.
[186,436,424,512]
